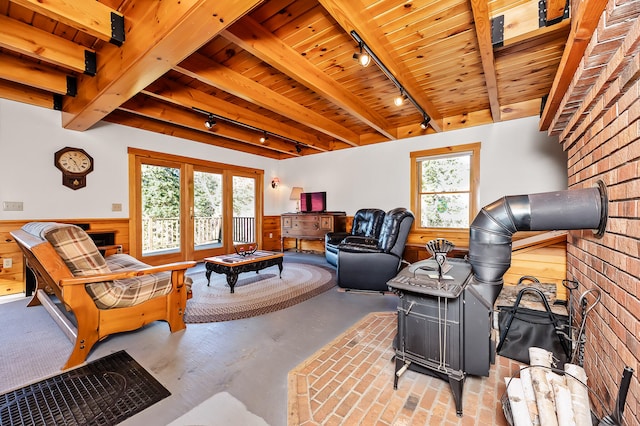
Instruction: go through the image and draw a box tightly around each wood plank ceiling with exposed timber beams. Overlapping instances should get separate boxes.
[0,0,571,159]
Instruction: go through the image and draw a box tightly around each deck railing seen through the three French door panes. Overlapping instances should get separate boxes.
[142,217,256,253]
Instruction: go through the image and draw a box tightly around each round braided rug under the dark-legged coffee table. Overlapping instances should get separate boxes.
[184,262,336,324]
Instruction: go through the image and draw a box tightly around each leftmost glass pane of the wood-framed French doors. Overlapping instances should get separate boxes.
[141,164,181,256]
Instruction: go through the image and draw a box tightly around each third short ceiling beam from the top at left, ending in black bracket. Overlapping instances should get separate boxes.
[0,53,76,96]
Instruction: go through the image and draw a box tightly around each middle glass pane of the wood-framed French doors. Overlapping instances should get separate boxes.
[193,170,224,250]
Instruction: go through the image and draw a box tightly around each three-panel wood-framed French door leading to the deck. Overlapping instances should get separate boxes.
[129,148,263,264]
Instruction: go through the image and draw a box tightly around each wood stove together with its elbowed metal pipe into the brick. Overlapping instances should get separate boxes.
[387,186,608,416]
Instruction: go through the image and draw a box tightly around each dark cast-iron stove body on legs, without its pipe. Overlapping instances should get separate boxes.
[387,259,495,416]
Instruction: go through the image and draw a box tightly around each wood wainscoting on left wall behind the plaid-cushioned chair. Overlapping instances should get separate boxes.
[0,219,129,296]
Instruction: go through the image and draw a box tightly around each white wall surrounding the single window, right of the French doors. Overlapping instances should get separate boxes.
[278,117,567,215]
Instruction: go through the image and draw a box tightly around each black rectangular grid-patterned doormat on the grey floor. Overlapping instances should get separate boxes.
[0,351,171,426]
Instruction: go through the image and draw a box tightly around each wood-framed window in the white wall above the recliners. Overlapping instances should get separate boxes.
[411,143,480,229]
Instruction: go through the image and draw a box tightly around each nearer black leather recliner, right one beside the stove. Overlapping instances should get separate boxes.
[337,208,414,291]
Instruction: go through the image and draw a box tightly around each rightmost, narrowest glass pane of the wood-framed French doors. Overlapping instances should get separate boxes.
[233,176,257,244]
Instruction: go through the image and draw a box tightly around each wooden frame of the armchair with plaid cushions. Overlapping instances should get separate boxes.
[11,230,196,370]
